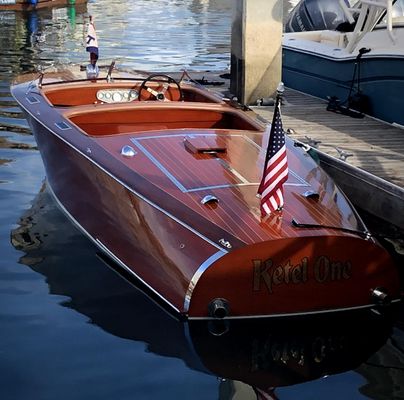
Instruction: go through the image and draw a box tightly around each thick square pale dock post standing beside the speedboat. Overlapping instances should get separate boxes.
[230,0,283,104]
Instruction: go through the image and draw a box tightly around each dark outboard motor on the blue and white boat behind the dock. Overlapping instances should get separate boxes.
[285,0,350,32]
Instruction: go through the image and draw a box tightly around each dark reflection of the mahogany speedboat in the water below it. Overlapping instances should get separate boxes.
[11,186,391,399]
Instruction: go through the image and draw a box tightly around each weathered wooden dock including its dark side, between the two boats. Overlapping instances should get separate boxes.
[253,89,404,228]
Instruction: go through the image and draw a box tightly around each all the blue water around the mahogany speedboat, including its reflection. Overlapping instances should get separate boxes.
[0,0,404,400]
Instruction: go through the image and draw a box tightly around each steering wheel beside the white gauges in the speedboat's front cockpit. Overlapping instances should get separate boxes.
[139,74,184,101]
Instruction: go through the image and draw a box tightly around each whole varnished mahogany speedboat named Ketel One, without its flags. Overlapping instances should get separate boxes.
[11,66,399,319]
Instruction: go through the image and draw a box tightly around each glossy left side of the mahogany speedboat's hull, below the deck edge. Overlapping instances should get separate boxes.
[27,115,220,313]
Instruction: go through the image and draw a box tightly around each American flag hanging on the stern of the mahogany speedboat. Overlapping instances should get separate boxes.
[258,96,288,217]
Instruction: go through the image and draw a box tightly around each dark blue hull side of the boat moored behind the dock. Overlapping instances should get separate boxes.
[282,39,404,125]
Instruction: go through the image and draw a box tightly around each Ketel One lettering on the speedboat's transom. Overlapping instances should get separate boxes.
[252,256,352,293]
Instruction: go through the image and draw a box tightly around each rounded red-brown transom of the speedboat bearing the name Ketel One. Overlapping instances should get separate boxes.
[185,236,400,319]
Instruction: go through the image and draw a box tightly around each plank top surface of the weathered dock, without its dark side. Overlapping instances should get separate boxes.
[254,89,404,188]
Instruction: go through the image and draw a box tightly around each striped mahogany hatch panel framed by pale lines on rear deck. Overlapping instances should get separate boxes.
[131,133,310,193]
